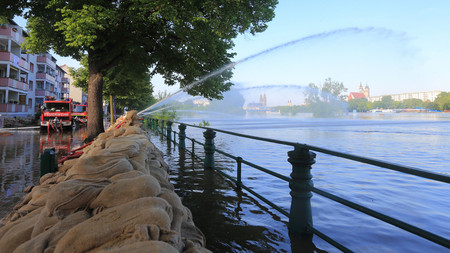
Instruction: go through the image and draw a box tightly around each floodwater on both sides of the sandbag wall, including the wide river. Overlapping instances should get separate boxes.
[0,113,450,252]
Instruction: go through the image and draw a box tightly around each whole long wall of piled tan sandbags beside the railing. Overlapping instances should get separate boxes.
[0,111,210,253]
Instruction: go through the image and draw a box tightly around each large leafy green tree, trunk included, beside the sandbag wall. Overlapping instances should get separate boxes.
[25,0,277,139]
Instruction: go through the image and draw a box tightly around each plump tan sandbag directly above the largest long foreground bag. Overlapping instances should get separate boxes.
[90,175,161,209]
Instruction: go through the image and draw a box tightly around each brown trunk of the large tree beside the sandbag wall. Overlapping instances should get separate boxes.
[85,54,105,142]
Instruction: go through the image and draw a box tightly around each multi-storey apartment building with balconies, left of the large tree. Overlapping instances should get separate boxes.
[0,20,70,117]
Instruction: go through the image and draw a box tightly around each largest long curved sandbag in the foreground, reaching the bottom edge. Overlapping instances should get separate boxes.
[55,197,173,253]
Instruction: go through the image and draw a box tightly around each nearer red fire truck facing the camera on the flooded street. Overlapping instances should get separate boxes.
[41,97,73,132]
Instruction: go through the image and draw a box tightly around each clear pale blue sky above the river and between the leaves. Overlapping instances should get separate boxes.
[15,0,450,105]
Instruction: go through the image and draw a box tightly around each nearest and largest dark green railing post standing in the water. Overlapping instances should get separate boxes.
[288,146,316,237]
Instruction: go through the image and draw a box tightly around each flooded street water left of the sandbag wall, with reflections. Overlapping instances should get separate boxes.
[0,128,86,217]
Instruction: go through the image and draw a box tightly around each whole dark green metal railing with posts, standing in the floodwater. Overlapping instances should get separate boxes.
[145,118,450,252]
